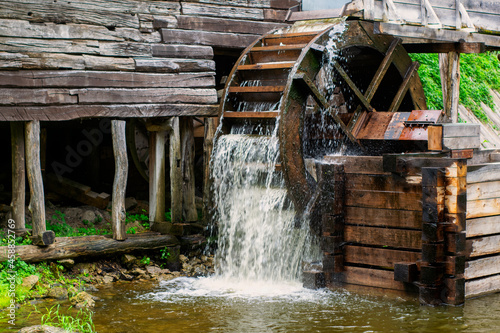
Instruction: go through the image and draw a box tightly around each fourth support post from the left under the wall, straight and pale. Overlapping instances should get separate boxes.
[149,131,167,224]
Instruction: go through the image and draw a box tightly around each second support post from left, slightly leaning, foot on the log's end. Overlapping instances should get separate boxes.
[25,120,55,246]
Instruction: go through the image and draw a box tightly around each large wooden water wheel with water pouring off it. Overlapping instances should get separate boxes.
[220,19,426,211]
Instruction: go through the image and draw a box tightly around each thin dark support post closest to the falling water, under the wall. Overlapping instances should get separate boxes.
[203,118,217,224]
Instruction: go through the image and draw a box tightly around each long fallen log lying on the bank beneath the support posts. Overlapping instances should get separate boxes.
[0,233,179,262]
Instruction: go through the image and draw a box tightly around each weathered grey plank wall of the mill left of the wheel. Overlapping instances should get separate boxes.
[0,0,298,121]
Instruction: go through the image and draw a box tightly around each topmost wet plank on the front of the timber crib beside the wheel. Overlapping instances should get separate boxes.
[324,155,390,175]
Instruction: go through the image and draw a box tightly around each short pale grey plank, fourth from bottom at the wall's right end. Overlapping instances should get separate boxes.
[135,58,215,73]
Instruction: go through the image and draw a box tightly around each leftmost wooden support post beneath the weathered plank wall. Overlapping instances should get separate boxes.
[10,121,26,231]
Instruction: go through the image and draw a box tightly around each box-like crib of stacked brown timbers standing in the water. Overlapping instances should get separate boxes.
[316,149,500,305]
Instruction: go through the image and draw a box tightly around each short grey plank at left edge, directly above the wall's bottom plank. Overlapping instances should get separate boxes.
[0,88,78,105]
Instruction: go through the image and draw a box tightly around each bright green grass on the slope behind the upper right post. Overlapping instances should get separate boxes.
[410,52,500,122]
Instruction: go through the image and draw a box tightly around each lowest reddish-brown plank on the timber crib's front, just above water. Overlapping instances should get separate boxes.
[342,266,406,290]
